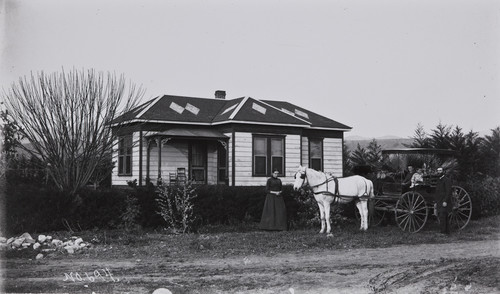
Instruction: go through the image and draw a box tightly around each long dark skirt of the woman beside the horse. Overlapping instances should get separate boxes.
[259,193,287,231]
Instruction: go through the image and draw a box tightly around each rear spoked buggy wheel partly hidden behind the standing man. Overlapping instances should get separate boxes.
[448,186,472,230]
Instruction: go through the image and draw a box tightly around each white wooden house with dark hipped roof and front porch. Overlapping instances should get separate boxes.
[112,91,351,186]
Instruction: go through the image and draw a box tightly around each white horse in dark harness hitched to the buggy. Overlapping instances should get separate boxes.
[293,166,375,235]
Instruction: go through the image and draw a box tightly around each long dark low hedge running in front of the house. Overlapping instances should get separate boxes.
[2,177,500,235]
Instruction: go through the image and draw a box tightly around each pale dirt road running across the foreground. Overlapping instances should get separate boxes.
[2,240,500,293]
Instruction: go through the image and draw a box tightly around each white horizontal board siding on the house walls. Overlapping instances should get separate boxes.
[112,132,343,186]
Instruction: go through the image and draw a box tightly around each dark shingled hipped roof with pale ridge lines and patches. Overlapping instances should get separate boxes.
[114,95,351,131]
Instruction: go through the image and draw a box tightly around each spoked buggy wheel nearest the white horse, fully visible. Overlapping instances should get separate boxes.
[395,191,428,233]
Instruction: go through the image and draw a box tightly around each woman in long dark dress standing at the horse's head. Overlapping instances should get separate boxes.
[260,170,287,231]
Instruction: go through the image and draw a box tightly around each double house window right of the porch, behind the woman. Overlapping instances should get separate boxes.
[253,136,285,176]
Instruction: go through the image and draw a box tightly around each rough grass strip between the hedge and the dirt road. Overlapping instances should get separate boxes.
[6,216,500,259]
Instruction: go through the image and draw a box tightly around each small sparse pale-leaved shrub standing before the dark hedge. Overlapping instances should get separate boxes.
[156,182,196,233]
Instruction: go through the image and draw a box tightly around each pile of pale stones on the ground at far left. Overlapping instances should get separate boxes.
[0,233,91,259]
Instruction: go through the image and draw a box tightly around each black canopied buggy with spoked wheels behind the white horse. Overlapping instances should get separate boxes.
[357,148,472,233]
